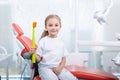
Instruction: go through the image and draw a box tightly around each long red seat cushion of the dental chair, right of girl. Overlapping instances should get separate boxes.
[65,65,119,80]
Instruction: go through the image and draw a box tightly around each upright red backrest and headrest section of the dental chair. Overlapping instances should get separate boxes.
[12,23,41,80]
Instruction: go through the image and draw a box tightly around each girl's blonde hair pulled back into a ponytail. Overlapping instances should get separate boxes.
[40,15,61,39]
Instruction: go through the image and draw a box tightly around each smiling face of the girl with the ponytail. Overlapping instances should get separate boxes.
[45,18,61,37]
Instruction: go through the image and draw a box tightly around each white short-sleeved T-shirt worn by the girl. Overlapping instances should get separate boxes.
[36,36,68,68]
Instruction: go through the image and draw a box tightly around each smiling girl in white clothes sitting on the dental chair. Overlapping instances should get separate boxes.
[31,15,77,80]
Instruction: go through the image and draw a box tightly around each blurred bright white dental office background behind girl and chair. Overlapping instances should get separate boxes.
[0,0,120,80]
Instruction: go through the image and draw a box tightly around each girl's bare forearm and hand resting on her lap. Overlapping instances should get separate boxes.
[53,57,66,75]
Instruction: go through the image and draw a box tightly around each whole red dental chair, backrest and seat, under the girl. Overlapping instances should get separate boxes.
[12,23,119,80]
